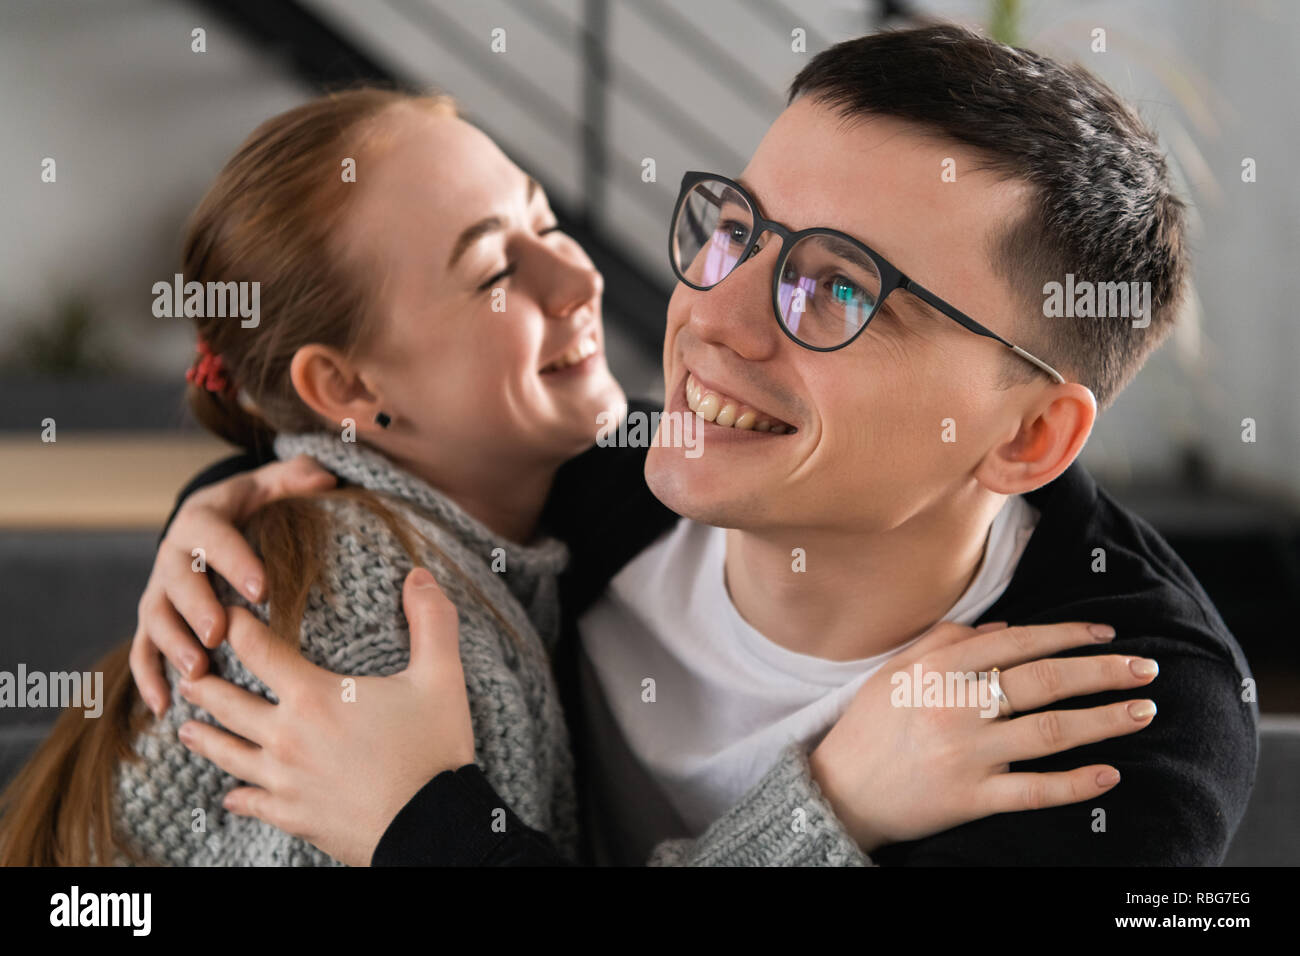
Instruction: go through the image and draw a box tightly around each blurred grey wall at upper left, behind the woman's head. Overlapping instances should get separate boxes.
[0,0,306,377]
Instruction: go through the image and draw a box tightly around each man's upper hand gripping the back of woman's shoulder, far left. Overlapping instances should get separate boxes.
[131,455,334,717]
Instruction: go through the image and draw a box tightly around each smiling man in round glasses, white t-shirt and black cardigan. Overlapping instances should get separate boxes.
[134,27,1257,865]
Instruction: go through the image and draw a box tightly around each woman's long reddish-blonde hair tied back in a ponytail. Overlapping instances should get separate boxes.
[0,88,465,866]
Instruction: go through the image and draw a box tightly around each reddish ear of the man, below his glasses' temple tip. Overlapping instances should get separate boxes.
[975,382,1097,494]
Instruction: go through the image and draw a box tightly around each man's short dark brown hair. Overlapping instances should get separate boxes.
[790,25,1187,407]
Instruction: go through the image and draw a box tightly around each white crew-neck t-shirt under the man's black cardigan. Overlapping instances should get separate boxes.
[579,496,1039,853]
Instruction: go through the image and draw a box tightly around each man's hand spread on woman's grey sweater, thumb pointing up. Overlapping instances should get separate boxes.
[179,568,475,866]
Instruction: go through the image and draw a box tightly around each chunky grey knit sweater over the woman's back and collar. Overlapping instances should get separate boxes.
[114,433,576,866]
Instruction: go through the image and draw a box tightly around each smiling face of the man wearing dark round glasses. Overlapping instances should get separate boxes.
[646,99,1045,532]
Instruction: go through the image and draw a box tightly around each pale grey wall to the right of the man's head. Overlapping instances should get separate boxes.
[924,0,1300,509]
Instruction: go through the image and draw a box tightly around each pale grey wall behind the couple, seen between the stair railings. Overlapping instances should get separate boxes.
[0,0,1300,499]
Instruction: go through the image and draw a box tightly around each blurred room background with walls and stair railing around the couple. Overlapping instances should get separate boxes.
[0,0,1300,864]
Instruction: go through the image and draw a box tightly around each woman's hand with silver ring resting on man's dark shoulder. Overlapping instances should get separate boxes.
[809,622,1156,853]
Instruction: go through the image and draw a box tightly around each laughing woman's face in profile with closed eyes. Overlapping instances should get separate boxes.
[343,109,624,480]
